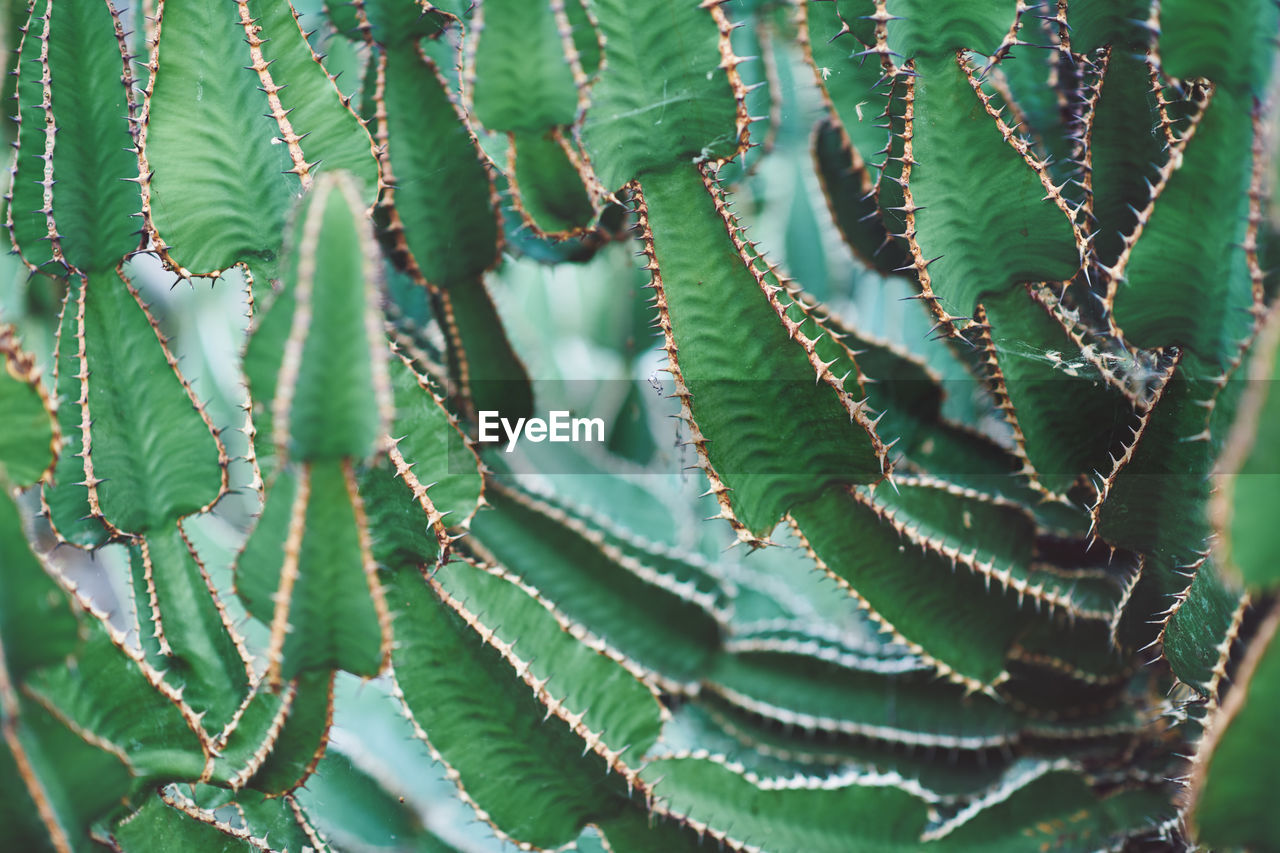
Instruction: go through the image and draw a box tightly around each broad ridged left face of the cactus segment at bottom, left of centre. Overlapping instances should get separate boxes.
[388,564,645,847]
